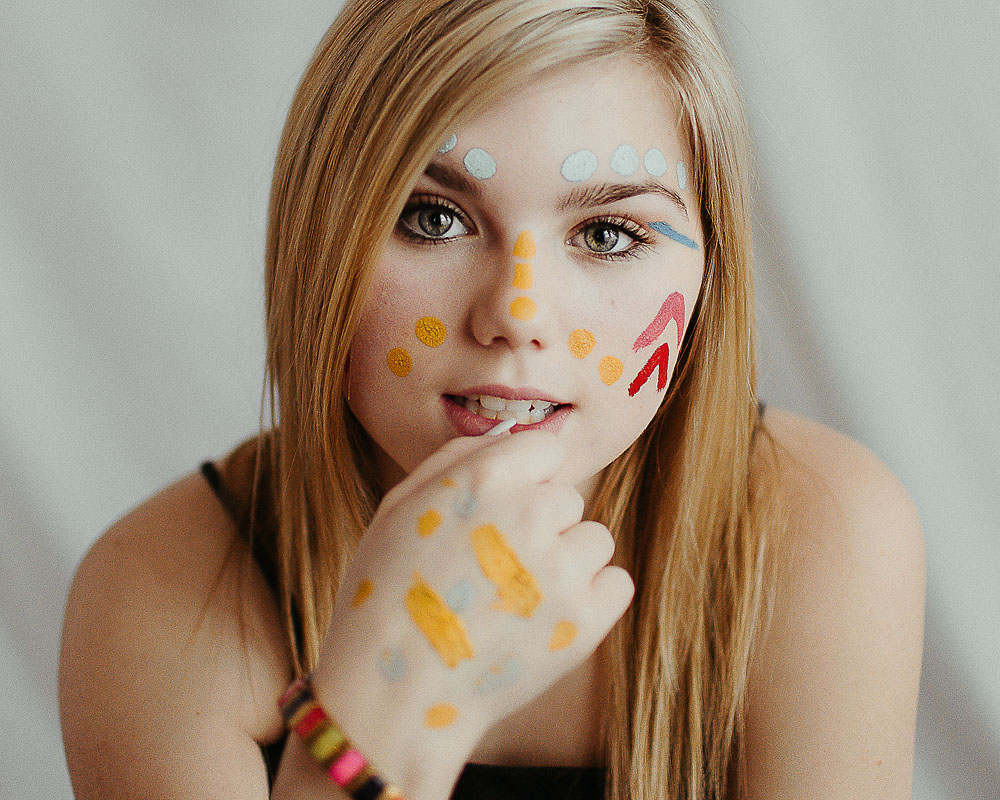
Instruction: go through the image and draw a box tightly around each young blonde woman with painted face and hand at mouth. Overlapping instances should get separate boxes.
[60,0,924,800]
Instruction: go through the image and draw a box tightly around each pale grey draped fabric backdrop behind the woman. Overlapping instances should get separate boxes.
[0,0,1000,800]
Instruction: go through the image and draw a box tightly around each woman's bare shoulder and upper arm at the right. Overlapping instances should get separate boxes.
[746,408,925,800]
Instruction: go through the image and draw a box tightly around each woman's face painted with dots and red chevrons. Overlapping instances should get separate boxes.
[350,58,704,489]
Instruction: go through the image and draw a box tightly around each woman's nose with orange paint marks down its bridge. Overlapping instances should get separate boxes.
[470,230,557,350]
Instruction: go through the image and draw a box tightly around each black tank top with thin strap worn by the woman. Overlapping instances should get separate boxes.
[201,456,604,800]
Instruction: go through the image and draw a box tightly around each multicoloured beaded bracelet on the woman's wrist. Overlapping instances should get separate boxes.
[278,677,405,800]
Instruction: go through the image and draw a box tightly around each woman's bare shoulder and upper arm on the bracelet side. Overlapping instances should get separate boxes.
[59,473,291,800]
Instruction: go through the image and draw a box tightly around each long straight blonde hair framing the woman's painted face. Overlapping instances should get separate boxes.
[258,0,780,800]
